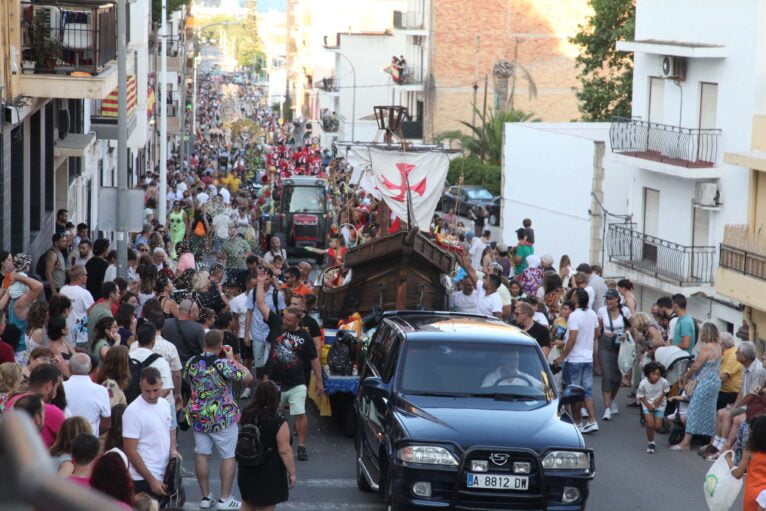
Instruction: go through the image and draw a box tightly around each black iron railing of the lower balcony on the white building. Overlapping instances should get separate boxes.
[607,224,716,286]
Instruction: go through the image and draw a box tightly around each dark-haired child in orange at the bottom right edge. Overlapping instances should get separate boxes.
[726,415,766,511]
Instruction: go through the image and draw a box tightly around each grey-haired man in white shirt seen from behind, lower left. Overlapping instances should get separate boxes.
[64,353,112,436]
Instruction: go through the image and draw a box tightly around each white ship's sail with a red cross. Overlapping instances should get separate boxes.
[369,148,450,231]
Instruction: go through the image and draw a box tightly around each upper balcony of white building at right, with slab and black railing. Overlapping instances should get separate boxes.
[609,117,721,179]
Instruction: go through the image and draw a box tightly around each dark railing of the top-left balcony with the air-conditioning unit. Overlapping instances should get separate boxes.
[21,0,117,74]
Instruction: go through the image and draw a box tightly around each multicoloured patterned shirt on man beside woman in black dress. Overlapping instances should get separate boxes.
[184,353,245,433]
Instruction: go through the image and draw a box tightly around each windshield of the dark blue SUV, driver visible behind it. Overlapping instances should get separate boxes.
[400,341,553,401]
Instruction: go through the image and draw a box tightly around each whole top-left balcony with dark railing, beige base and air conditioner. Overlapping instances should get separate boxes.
[19,0,117,99]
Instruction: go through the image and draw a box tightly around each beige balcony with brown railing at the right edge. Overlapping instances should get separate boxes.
[715,225,766,310]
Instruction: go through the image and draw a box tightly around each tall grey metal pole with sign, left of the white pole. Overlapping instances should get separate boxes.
[117,0,130,278]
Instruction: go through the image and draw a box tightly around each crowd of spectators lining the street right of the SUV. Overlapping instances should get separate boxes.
[448,217,766,496]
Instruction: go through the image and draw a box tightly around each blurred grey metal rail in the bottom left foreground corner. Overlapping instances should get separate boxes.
[0,411,122,511]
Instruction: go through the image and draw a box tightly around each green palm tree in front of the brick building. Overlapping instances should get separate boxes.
[436,108,540,165]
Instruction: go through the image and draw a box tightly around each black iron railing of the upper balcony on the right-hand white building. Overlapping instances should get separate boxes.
[609,117,721,168]
